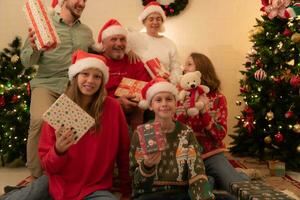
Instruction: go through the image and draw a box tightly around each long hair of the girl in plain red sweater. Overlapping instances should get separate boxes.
[65,74,107,130]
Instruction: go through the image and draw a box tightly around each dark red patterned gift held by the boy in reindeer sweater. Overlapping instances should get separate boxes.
[137,122,167,155]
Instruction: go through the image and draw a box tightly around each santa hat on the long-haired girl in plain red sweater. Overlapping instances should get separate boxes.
[68,50,109,84]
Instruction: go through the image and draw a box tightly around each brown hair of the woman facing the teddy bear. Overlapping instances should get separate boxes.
[190,52,221,91]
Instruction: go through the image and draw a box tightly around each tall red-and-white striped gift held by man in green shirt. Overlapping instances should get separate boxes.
[23,0,60,50]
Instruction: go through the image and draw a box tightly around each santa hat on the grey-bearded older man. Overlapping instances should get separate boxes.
[93,19,127,51]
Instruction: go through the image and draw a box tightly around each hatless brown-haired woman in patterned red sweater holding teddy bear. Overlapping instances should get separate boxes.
[176,53,249,199]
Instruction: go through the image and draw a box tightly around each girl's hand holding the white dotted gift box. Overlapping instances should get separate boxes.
[55,126,75,154]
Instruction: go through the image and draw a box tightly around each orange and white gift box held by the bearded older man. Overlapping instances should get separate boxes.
[115,77,147,102]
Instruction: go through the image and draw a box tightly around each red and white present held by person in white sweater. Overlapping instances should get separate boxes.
[145,58,170,79]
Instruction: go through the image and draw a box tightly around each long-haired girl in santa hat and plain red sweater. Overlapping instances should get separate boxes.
[3,51,131,200]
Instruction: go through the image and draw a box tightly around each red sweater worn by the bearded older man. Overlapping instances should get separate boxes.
[106,55,151,97]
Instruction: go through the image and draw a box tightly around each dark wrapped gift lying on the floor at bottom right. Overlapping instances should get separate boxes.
[231,181,293,200]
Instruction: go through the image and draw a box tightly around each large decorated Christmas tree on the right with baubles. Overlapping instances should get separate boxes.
[230,0,300,170]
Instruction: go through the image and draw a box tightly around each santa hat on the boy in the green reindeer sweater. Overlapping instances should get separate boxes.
[139,78,178,109]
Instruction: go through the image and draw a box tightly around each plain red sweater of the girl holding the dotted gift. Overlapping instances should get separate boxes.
[39,97,131,200]
